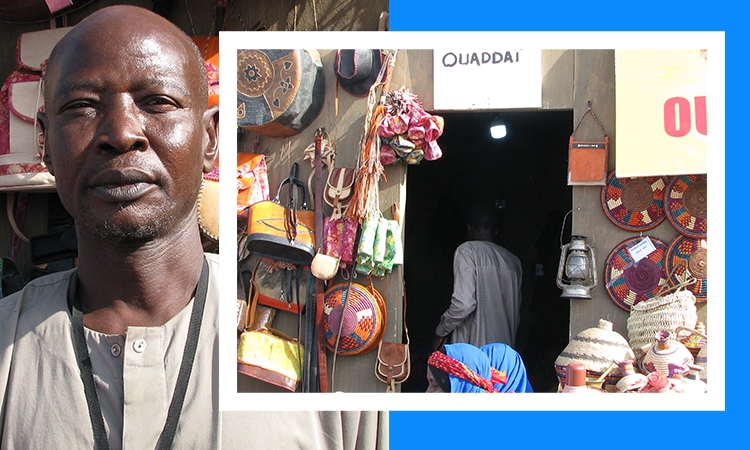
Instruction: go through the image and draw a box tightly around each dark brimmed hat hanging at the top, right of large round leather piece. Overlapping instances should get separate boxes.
[333,50,382,97]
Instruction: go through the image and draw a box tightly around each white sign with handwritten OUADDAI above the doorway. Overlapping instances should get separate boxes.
[433,46,542,110]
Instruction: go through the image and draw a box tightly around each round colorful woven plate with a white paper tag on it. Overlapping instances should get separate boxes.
[604,236,668,312]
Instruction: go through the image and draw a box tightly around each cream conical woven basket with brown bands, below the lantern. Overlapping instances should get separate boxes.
[555,319,636,392]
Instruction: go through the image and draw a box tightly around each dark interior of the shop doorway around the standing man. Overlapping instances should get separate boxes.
[402,111,573,392]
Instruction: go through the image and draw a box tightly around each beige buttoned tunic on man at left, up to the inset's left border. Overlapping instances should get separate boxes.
[0,254,220,450]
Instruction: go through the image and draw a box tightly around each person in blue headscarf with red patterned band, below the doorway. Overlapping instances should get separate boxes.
[427,343,497,392]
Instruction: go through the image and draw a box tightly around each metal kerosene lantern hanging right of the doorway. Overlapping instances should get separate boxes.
[557,235,597,299]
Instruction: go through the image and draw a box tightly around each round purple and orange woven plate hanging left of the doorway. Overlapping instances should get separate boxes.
[323,283,386,355]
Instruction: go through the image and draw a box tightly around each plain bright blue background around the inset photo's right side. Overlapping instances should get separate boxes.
[390,0,750,450]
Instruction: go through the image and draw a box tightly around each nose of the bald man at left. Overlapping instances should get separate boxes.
[96,95,148,152]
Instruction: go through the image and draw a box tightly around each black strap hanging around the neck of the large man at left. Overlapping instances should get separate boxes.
[68,257,208,450]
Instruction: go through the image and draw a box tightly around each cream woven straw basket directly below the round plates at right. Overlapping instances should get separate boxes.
[628,290,698,354]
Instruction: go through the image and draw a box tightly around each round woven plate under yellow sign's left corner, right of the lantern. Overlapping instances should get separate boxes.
[601,171,668,231]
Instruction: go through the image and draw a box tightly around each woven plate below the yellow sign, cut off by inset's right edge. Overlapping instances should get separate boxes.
[665,175,708,239]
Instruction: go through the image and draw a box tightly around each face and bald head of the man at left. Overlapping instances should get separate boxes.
[40,21,216,240]
